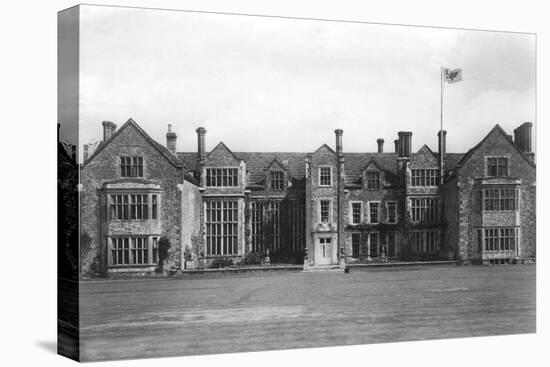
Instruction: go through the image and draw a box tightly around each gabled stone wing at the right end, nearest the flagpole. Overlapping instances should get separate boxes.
[444,125,536,263]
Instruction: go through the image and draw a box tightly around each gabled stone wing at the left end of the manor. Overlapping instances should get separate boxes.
[80,120,202,275]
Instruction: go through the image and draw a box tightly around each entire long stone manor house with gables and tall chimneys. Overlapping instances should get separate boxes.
[80,120,536,274]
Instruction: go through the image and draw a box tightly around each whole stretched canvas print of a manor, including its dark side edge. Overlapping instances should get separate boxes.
[57,5,537,361]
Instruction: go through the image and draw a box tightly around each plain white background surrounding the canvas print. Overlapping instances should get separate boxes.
[0,0,550,366]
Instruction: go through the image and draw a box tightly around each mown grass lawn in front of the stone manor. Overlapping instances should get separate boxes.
[80,265,536,361]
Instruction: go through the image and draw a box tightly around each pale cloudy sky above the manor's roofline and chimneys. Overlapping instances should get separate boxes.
[60,6,536,162]
